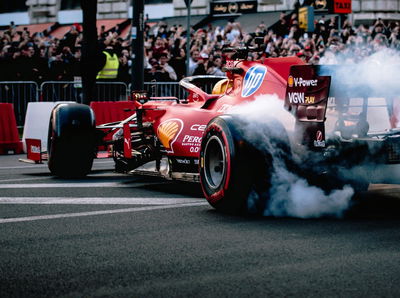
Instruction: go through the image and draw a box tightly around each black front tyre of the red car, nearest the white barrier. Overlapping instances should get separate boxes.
[47,103,96,178]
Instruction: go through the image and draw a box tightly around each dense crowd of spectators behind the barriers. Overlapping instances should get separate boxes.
[0,13,400,83]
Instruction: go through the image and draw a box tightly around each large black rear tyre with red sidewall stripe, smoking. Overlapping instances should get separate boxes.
[200,115,290,214]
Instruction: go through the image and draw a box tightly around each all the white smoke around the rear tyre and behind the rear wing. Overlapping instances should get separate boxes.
[230,49,400,218]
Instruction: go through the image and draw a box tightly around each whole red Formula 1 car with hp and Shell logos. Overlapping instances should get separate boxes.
[28,49,400,213]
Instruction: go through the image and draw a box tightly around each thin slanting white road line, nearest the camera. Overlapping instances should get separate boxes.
[0,202,208,224]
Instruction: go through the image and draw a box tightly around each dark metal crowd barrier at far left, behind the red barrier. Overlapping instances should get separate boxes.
[0,81,39,126]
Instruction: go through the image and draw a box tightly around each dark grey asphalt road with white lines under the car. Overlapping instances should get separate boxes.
[0,156,400,297]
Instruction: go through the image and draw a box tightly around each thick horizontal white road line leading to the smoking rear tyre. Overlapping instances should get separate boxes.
[0,197,205,205]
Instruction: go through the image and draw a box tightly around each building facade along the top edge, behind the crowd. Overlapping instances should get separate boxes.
[0,0,400,25]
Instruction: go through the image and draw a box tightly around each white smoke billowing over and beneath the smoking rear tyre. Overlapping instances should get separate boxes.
[230,95,354,218]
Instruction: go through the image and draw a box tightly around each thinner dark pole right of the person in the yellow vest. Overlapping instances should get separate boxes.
[131,0,144,91]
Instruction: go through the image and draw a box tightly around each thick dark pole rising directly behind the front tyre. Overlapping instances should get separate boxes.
[81,0,98,105]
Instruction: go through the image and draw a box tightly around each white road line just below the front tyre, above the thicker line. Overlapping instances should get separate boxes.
[0,182,148,189]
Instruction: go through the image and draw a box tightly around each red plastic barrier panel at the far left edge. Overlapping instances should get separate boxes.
[0,103,22,154]
